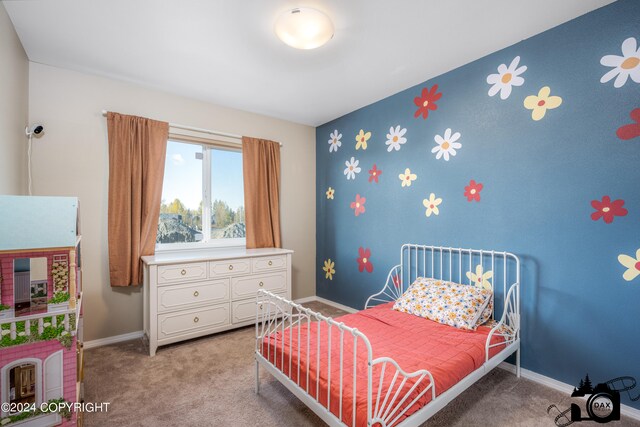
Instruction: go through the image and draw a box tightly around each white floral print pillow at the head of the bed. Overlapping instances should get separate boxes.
[393,277,492,330]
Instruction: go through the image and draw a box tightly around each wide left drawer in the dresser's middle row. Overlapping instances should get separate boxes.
[158,279,229,312]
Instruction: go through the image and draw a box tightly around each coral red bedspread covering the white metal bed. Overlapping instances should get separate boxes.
[260,303,504,426]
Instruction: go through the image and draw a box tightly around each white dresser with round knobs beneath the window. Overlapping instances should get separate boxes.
[142,248,293,356]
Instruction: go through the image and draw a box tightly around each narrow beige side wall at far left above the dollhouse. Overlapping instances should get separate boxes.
[0,2,29,194]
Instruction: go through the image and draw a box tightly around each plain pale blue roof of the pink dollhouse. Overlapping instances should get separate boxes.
[0,196,79,251]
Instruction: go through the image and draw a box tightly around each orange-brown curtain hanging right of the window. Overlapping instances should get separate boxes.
[242,136,282,249]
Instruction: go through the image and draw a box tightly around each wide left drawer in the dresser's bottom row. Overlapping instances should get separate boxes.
[158,303,230,340]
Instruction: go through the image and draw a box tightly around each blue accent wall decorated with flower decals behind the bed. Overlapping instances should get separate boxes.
[316,0,640,408]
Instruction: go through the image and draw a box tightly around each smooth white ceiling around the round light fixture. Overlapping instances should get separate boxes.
[3,0,612,126]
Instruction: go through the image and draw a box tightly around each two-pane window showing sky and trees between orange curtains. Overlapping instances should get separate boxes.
[156,139,245,249]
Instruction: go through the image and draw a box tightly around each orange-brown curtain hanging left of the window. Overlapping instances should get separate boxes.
[107,113,169,286]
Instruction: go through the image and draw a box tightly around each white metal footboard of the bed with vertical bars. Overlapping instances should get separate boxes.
[255,290,436,426]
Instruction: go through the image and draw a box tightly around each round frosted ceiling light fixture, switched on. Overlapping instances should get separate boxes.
[276,7,333,49]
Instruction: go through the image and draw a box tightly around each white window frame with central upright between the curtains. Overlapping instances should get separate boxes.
[156,134,247,253]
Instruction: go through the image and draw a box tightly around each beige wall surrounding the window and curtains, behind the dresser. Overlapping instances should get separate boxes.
[29,63,316,340]
